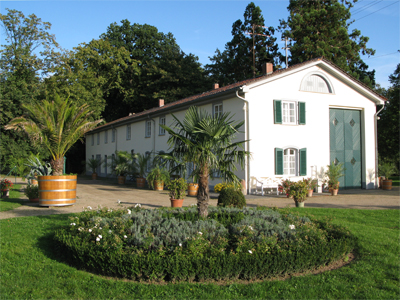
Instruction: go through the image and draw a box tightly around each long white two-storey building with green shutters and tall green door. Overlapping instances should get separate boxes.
[86,58,386,192]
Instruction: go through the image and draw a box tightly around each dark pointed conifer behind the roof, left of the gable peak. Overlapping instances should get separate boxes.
[206,2,282,85]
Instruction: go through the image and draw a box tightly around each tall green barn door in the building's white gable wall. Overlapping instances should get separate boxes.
[329,109,361,189]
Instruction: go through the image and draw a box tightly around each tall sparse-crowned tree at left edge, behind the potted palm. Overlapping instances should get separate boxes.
[0,9,59,169]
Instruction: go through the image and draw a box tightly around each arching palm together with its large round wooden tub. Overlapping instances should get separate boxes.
[5,95,103,206]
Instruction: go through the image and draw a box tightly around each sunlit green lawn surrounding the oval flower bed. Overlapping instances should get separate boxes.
[0,193,400,299]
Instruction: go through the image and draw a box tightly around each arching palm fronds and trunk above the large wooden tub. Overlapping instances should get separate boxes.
[5,95,103,175]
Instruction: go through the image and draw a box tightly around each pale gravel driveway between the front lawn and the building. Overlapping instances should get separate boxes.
[0,177,400,219]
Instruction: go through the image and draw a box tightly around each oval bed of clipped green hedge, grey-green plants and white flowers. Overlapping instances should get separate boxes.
[54,207,356,281]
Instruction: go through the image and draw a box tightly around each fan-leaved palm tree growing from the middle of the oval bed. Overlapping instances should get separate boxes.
[161,107,249,217]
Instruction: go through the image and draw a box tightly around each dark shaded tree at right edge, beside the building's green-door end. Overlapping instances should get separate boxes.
[378,64,400,170]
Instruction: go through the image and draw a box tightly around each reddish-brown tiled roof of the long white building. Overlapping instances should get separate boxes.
[93,57,386,131]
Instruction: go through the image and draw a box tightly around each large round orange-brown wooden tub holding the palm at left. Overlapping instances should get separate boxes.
[39,175,77,206]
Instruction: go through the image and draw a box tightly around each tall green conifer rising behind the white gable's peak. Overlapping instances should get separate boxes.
[279,0,375,87]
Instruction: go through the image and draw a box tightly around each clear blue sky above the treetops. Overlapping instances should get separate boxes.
[0,0,400,87]
